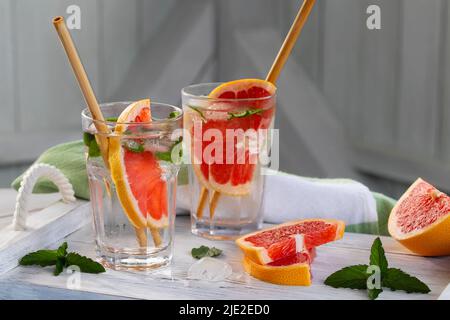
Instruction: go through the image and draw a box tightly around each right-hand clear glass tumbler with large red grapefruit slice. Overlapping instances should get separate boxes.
[182,83,276,240]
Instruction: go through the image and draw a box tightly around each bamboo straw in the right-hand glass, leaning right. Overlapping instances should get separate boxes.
[197,0,316,219]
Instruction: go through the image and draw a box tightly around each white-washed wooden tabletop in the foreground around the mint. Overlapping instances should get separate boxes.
[0,210,450,300]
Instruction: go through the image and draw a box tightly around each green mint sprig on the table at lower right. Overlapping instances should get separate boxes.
[325,238,431,300]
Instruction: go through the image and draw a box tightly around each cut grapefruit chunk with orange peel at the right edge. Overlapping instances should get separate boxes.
[388,178,450,256]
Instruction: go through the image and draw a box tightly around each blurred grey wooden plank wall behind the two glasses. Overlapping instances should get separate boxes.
[0,0,450,200]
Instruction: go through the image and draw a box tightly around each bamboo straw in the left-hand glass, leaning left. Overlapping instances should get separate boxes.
[53,17,161,247]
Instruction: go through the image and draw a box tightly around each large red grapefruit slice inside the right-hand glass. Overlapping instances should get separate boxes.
[191,79,276,196]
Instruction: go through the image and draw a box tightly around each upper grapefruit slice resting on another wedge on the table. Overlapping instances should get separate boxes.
[236,219,345,265]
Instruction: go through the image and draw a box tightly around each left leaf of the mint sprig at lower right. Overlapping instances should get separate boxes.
[325,264,369,289]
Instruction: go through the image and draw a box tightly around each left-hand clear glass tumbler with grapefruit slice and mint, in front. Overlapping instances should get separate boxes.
[82,102,182,270]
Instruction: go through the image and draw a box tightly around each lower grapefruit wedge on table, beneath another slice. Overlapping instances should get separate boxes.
[243,251,312,286]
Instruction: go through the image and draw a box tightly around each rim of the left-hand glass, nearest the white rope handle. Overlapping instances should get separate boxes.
[81,101,183,125]
